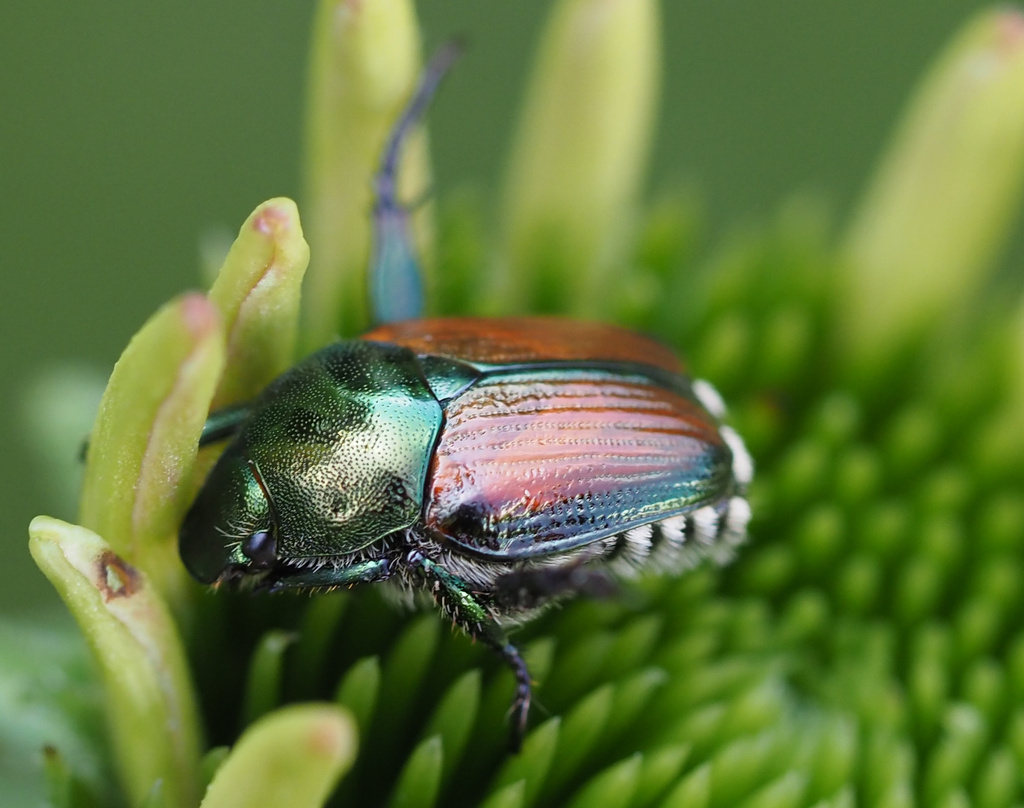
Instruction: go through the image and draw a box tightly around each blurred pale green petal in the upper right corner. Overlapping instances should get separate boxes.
[838,9,1024,373]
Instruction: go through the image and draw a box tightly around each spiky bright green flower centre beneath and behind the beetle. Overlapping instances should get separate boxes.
[34,192,1007,808]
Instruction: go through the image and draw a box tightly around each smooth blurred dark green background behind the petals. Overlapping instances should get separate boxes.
[0,0,1007,611]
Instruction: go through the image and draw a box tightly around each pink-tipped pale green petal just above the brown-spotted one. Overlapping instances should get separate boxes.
[79,294,225,607]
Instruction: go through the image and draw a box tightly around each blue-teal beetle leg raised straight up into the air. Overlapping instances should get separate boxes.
[369,42,461,324]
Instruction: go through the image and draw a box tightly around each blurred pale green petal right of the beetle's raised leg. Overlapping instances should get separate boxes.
[502,0,660,315]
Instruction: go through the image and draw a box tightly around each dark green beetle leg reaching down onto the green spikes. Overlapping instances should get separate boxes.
[409,551,534,753]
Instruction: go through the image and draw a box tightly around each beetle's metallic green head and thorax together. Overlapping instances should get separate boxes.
[182,341,441,581]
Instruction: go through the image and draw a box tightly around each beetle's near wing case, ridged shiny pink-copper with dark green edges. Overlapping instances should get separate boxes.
[425,366,732,560]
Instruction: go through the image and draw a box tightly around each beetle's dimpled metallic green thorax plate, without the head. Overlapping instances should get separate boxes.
[245,341,441,557]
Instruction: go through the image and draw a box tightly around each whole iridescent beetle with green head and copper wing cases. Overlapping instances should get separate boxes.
[179,42,753,749]
